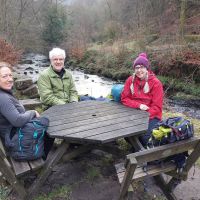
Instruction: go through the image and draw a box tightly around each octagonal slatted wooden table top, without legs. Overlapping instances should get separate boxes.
[43,101,149,144]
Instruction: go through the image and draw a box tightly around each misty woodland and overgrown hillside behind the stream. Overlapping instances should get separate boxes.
[0,0,200,96]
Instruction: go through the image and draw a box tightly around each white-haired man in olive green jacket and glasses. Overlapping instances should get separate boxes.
[37,48,78,109]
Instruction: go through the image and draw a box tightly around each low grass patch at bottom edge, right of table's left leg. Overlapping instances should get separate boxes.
[34,186,72,200]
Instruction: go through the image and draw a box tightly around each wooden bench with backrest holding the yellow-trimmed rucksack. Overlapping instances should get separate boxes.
[115,137,200,200]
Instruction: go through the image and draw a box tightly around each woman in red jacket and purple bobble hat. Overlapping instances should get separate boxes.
[121,53,163,146]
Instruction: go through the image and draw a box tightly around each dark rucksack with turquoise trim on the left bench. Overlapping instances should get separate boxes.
[5,117,49,160]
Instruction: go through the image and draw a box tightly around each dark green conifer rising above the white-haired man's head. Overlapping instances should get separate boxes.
[42,5,67,46]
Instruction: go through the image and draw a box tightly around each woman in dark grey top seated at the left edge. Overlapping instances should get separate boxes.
[0,62,53,158]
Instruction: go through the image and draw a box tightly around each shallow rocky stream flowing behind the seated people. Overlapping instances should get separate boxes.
[15,53,200,119]
